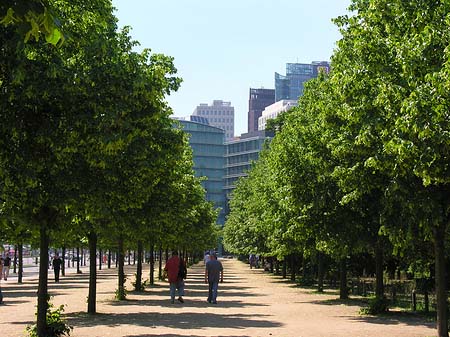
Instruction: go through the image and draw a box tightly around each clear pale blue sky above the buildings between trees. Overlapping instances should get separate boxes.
[113,0,350,135]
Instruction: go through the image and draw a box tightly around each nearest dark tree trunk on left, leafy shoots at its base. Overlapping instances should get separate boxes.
[36,222,49,337]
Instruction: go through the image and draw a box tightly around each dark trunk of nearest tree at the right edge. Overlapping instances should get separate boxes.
[433,220,448,337]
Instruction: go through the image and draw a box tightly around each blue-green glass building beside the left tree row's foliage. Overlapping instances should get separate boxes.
[178,119,227,226]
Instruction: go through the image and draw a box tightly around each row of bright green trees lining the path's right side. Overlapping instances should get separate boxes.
[224,0,450,337]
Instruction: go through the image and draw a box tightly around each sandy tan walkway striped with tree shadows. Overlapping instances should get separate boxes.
[0,260,436,337]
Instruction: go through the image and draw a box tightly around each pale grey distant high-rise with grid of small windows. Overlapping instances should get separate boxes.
[192,100,234,140]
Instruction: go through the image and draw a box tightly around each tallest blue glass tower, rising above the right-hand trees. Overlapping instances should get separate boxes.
[275,61,330,102]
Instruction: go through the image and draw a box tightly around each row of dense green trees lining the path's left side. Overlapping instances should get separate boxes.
[0,0,217,336]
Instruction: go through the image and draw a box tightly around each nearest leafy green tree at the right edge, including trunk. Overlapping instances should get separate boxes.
[333,0,449,337]
